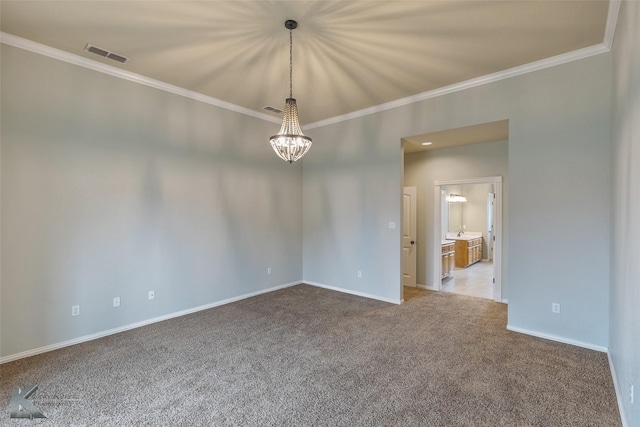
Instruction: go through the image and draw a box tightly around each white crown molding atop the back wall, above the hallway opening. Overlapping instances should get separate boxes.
[303,43,610,130]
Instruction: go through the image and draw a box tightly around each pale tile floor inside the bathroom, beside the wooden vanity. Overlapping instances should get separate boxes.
[442,261,493,299]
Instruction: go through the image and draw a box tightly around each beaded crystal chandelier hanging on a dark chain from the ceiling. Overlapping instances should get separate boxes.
[269,19,311,163]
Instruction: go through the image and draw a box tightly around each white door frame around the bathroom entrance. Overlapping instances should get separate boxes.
[433,176,502,302]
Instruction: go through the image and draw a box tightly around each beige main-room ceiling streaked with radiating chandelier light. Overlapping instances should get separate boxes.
[0,0,609,124]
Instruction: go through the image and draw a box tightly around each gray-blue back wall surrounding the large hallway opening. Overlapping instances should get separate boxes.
[303,54,611,347]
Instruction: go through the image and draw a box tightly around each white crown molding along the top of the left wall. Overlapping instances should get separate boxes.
[0,32,281,123]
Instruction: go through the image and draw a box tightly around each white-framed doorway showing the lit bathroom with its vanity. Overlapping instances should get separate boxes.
[433,176,502,301]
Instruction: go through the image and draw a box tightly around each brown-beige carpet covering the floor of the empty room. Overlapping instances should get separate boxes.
[0,285,620,426]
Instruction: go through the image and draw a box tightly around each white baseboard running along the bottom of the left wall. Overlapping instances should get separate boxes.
[0,282,302,364]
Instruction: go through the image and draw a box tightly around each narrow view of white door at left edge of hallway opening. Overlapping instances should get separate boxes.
[402,187,417,287]
